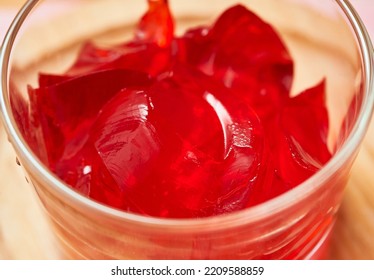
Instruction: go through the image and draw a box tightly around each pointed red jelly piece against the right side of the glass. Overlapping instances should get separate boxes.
[248,81,331,203]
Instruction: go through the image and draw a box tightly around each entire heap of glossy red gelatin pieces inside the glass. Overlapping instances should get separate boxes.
[18,1,331,218]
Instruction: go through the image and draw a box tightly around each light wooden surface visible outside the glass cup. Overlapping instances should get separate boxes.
[0,0,374,259]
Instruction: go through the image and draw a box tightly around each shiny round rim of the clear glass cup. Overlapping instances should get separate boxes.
[0,0,374,230]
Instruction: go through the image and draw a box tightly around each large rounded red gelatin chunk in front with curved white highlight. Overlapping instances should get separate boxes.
[90,69,263,217]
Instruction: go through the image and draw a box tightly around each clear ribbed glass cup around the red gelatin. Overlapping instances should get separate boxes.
[1,0,374,259]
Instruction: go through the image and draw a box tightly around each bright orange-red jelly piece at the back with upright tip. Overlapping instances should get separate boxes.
[67,0,174,76]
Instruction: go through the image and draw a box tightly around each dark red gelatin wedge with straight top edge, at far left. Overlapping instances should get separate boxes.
[29,69,151,166]
